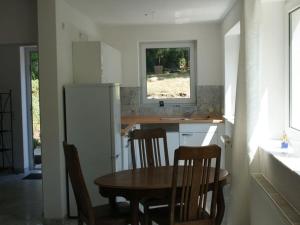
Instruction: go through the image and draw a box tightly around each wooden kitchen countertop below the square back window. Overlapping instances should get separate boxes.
[121,115,224,135]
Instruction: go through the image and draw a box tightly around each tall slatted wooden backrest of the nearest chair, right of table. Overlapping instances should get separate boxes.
[170,145,221,225]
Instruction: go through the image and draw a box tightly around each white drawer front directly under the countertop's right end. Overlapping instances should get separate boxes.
[179,123,218,133]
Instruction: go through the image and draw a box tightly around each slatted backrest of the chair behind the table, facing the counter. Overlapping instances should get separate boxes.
[129,128,169,169]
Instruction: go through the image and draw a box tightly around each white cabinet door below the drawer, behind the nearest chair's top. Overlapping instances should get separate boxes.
[180,132,218,146]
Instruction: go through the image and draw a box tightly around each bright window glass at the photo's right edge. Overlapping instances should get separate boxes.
[289,8,300,130]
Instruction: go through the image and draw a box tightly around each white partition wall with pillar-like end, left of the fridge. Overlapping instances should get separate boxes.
[38,0,100,219]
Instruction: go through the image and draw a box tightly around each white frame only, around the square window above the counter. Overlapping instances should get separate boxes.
[140,41,197,104]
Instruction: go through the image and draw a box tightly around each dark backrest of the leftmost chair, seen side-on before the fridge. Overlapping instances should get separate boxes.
[63,142,95,224]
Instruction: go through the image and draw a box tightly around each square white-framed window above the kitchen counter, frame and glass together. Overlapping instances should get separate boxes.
[140,41,196,103]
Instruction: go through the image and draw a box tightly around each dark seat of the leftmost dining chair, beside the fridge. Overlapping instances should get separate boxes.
[94,202,130,225]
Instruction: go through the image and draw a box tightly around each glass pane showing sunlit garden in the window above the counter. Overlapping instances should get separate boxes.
[146,47,191,99]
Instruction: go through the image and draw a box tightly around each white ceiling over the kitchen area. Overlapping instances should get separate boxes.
[66,0,236,25]
